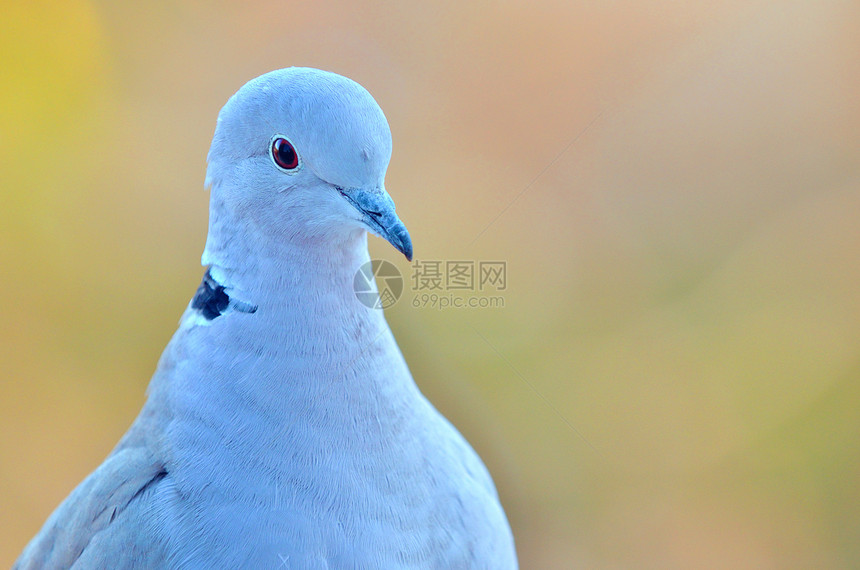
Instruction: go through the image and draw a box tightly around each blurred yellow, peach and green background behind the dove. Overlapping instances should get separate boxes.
[0,0,860,569]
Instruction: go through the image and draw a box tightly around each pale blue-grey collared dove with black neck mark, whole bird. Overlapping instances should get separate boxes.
[15,67,517,569]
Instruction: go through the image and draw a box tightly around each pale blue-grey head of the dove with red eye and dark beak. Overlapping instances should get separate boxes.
[206,67,412,260]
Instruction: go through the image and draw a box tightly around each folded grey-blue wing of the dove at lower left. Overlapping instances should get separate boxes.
[13,447,168,570]
